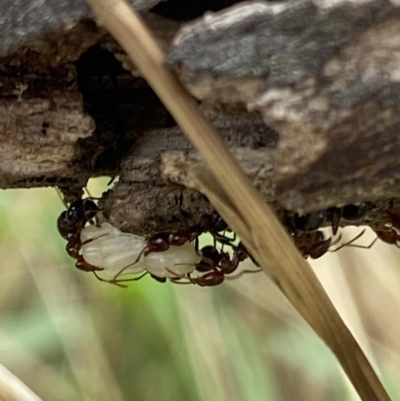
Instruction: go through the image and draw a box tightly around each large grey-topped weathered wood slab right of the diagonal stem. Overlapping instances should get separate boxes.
[167,0,400,211]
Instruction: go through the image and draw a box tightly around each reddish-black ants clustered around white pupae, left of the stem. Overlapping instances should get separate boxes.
[57,199,258,287]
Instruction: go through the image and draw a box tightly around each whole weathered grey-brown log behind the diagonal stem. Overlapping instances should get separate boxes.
[0,0,400,234]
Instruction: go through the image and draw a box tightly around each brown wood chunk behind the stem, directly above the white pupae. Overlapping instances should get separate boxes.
[100,115,278,234]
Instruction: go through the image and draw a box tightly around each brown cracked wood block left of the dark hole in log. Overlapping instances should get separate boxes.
[0,69,95,188]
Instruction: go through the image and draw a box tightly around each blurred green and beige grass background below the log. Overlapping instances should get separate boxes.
[0,179,400,401]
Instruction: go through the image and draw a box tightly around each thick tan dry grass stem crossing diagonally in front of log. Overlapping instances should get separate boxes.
[83,0,389,401]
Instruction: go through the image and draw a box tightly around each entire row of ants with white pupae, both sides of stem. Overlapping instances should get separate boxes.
[57,199,400,287]
